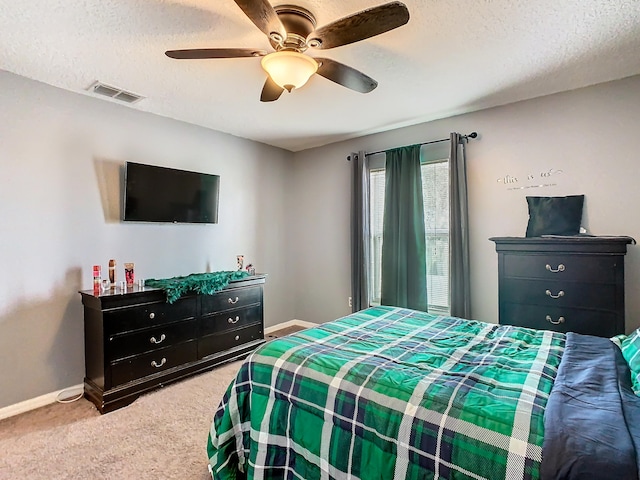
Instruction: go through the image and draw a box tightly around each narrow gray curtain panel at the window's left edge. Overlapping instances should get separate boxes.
[350,152,370,312]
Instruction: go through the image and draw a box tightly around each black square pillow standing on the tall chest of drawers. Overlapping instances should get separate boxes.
[527,195,584,237]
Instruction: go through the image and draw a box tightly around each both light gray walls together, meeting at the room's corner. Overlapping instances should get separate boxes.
[0,71,640,408]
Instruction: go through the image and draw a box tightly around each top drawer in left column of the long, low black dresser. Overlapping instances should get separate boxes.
[104,297,197,334]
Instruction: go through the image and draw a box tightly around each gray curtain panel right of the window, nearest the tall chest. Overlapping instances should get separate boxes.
[449,132,471,318]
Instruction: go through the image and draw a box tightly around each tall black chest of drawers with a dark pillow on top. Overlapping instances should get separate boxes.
[490,236,634,337]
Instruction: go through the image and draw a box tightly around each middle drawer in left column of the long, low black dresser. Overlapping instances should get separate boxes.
[107,319,198,360]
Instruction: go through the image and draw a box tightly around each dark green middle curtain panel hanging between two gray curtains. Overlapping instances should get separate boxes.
[380,145,428,312]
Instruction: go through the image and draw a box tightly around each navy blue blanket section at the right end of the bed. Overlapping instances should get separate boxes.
[541,333,640,480]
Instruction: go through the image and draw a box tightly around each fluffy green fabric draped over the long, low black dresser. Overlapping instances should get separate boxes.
[144,270,249,303]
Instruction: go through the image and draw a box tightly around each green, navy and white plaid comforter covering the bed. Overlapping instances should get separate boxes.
[207,307,565,480]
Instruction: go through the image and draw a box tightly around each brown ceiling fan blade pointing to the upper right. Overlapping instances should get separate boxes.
[307,2,409,50]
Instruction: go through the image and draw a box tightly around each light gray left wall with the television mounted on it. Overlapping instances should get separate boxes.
[0,71,294,408]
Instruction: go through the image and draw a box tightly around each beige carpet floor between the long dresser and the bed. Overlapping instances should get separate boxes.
[0,362,241,480]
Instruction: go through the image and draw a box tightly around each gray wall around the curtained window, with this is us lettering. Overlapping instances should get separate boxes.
[290,76,640,331]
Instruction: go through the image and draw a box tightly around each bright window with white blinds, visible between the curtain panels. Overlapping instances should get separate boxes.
[369,159,449,313]
